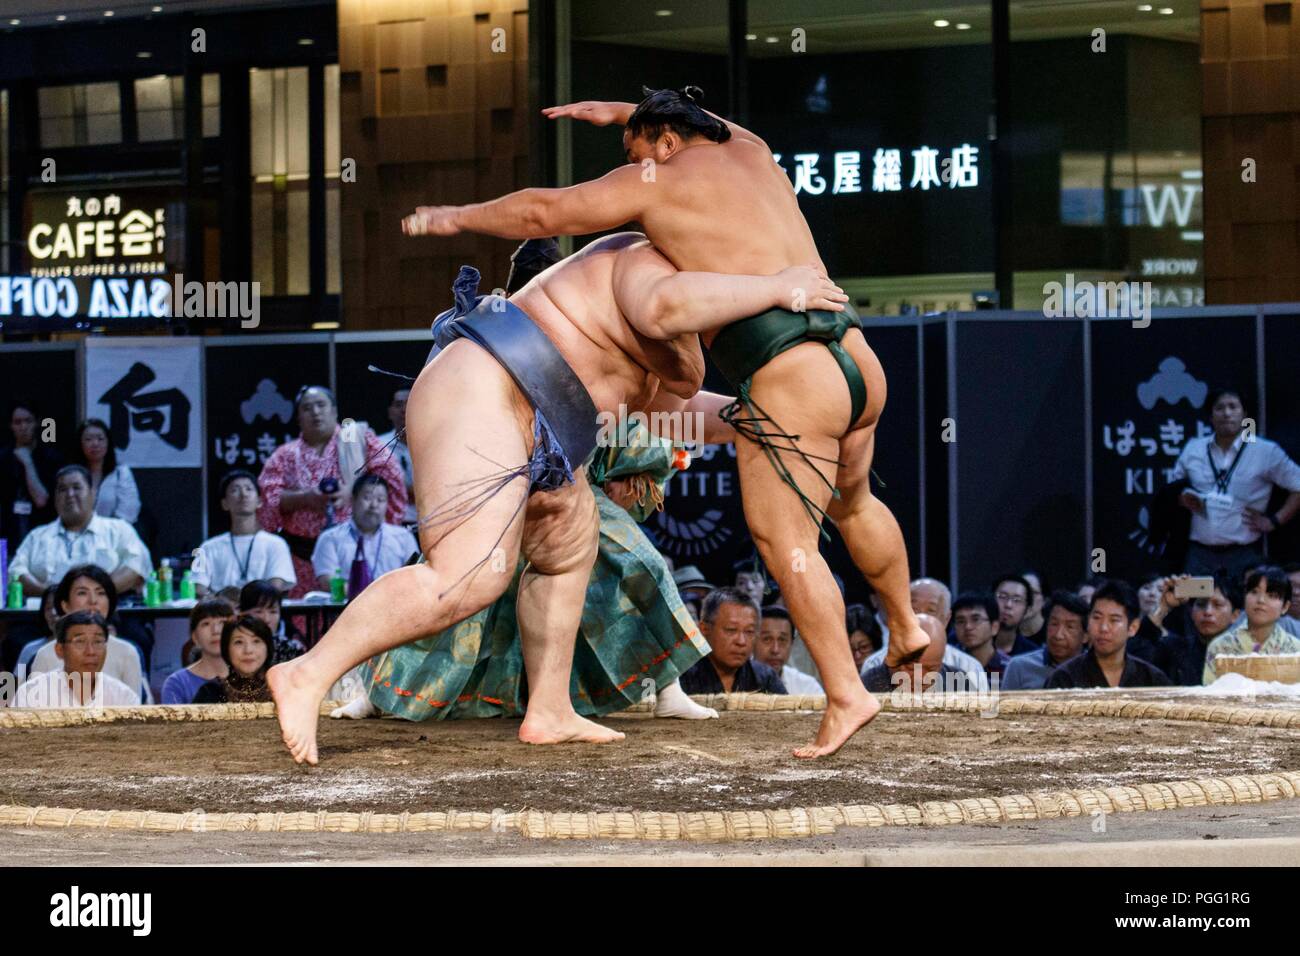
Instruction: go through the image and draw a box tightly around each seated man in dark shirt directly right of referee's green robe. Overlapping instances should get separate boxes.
[681,588,787,693]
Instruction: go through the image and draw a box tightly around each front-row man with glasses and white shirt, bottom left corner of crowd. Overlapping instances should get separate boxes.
[13,611,140,709]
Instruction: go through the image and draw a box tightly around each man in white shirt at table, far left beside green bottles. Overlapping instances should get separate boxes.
[9,464,152,597]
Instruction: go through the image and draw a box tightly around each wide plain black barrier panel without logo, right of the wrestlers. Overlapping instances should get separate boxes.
[954,319,1086,591]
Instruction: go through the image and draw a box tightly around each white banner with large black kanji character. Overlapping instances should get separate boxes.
[86,337,203,468]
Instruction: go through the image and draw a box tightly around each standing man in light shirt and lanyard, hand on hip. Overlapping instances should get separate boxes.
[1170,389,1300,579]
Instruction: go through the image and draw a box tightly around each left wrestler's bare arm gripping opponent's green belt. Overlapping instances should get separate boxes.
[614,242,849,339]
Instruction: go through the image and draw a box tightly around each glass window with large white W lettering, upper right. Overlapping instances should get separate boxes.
[1010,0,1205,310]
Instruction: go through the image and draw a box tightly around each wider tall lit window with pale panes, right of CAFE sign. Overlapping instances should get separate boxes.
[248,66,311,295]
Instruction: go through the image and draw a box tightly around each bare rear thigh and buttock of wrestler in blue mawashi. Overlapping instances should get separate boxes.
[407,338,532,568]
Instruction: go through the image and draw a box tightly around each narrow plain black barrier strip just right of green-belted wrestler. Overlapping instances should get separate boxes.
[925,317,957,581]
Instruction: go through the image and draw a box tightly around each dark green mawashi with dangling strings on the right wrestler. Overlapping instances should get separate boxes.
[709,306,867,540]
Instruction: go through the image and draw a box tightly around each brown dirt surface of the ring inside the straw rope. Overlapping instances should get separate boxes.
[0,711,1300,813]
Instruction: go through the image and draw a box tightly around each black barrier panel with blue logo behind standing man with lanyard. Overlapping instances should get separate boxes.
[1089,315,1257,580]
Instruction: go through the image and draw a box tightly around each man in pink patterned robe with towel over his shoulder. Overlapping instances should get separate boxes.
[257,385,406,597]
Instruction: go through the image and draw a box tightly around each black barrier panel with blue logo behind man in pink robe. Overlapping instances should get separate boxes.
[195,339,329,546]
